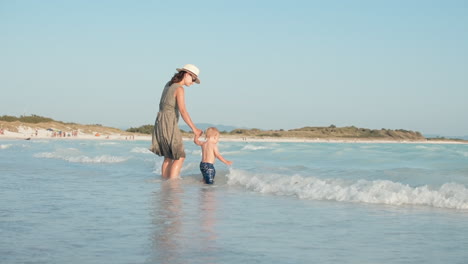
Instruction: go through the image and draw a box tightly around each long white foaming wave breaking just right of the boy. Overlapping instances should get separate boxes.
[227,169,468,209]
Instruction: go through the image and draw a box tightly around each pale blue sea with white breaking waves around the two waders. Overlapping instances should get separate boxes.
[0,139,468,263]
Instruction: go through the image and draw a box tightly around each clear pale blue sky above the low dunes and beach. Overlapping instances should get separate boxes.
[0,0,468,136]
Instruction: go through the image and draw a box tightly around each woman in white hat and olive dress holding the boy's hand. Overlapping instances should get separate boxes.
[150,64,203,179]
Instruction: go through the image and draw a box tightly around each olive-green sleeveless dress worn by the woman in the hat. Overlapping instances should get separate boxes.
[150,83,185,160]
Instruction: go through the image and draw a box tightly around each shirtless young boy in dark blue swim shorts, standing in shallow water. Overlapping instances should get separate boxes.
[193,127,232,184]
